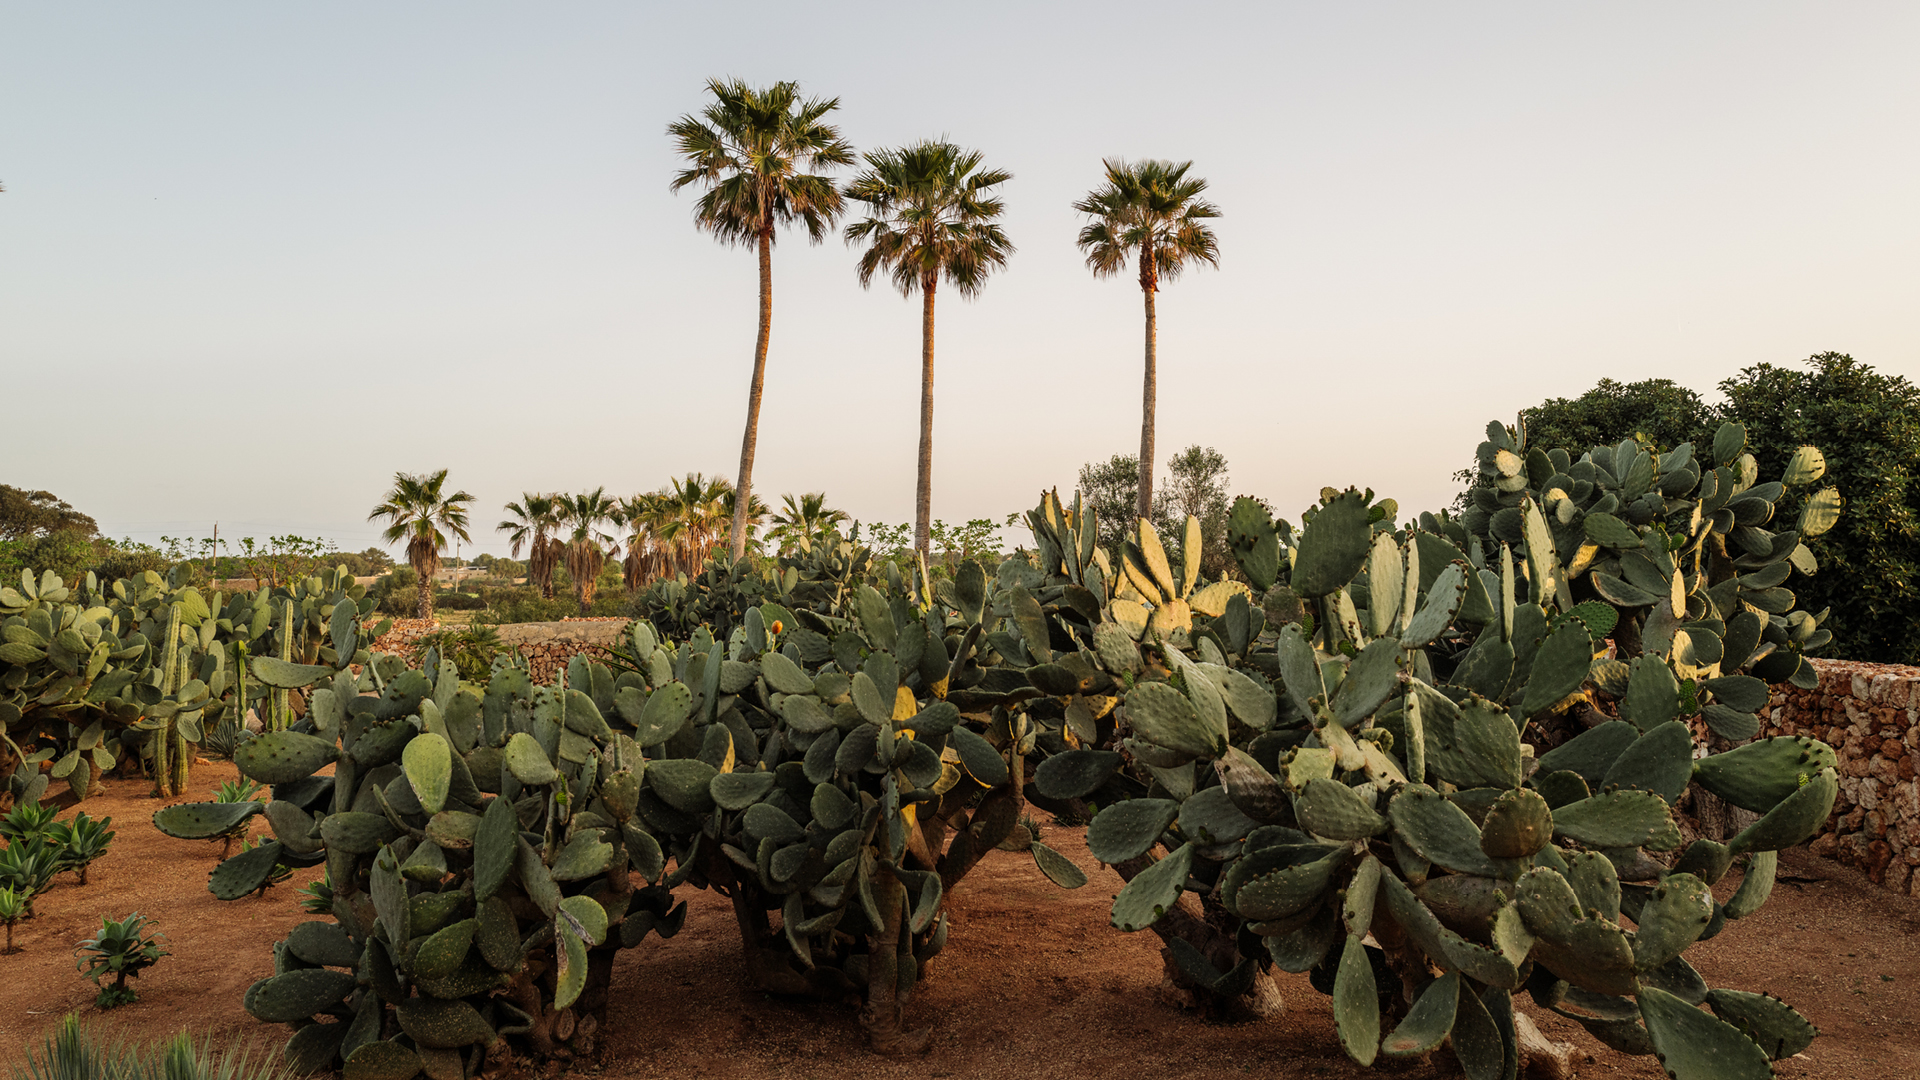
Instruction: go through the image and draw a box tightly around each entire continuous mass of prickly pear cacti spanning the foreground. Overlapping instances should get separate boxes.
[187,425,1836,1080]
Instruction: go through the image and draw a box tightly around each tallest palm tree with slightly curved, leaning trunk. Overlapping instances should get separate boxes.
[666,79,854,561]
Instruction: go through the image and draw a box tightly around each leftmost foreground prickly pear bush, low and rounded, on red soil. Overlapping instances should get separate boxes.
[185,638,693,1076]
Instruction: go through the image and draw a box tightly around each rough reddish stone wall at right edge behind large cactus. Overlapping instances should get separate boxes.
[1761,659,1920,896]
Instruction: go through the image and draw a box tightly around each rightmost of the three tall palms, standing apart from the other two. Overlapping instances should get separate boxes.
[1073,158,1219,517]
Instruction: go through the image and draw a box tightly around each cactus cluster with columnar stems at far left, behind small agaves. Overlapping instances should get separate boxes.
[0,569,389,801]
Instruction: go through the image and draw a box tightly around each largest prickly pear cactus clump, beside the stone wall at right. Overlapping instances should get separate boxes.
[1021,425,1837,1080]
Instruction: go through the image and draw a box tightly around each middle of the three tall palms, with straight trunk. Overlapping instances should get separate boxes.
[847,142,1014,555]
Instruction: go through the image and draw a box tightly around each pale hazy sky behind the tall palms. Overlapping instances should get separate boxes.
[0,0,1920,553]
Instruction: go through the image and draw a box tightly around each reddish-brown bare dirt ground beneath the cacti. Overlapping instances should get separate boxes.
[0,763,1920,1080]
